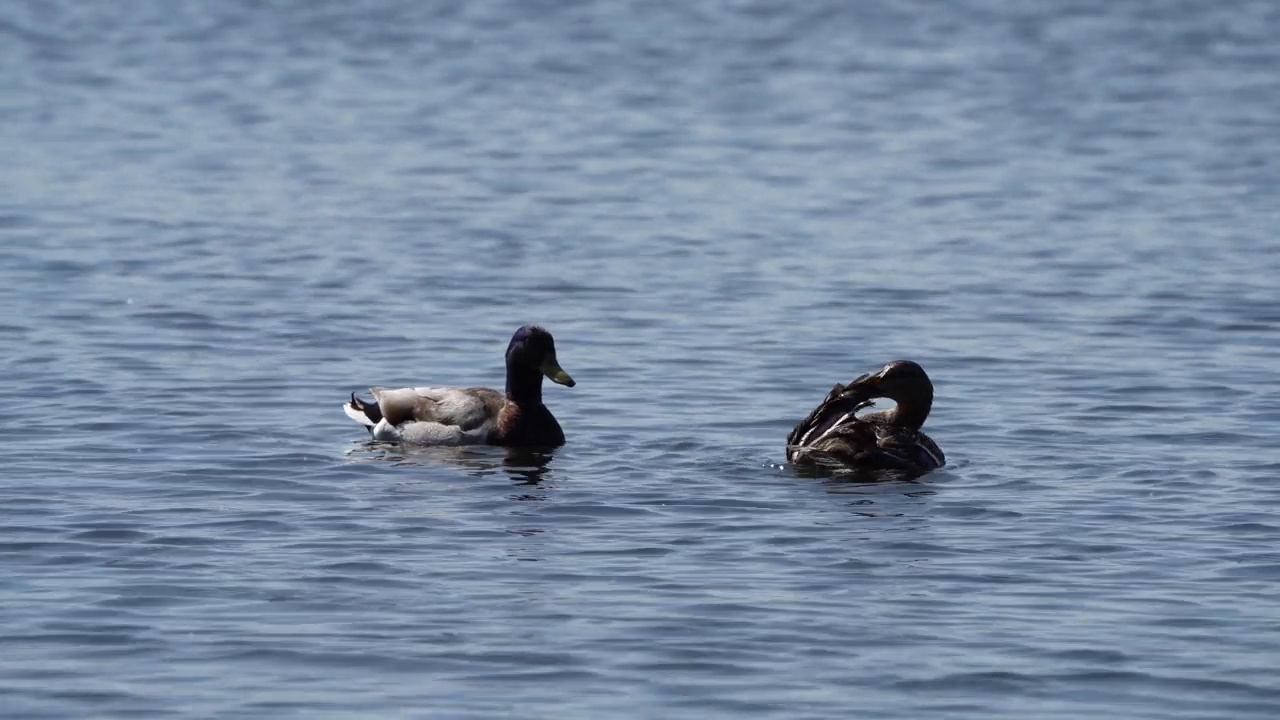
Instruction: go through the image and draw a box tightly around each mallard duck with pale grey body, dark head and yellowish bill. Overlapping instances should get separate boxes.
[342,325,575,447]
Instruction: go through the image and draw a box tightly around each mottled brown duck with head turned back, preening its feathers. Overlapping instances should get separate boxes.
[787,360,946,473]
